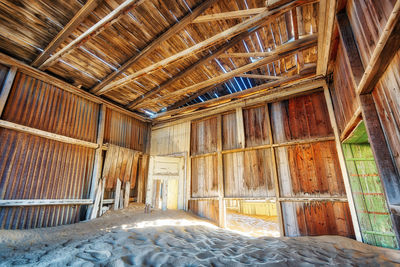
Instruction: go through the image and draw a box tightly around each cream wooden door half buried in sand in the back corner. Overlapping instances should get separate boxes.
[146,156,184,210]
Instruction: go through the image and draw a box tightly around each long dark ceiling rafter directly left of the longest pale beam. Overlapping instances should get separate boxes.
[90,0,217,93]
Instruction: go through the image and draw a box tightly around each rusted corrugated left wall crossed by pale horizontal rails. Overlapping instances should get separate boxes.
[0,68,149,229]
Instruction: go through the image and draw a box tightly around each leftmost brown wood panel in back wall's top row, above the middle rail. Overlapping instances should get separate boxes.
[190,117,217,155]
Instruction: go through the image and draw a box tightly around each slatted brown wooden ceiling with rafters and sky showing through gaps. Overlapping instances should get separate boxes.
[0,0,335,117]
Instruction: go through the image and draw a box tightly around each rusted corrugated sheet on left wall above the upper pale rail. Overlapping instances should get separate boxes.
[2,72,99,142]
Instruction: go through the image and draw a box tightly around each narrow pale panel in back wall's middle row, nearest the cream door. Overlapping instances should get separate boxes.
[191,155,218,197]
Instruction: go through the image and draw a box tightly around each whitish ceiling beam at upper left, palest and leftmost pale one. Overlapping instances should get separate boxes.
[38,0,145,70]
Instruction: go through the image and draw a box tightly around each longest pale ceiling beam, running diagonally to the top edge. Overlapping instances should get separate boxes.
[96,0,313,95]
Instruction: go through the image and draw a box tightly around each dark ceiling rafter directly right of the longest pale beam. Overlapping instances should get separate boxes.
[126,31,257,109]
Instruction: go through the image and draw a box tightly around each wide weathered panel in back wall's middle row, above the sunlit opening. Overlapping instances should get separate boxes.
[223,149,275,197]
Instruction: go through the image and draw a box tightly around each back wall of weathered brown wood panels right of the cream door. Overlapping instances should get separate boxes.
[189,91,354,237]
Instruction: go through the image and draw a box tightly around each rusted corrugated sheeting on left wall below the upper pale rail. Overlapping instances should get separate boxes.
[0,129,94,229]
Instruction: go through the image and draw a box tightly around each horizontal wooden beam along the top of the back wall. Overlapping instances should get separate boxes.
[152,78,325,127]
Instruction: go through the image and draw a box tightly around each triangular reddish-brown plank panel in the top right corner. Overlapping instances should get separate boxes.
[346,0,396,67]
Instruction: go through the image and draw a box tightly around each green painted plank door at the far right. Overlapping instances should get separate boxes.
[343,122,398,248]
